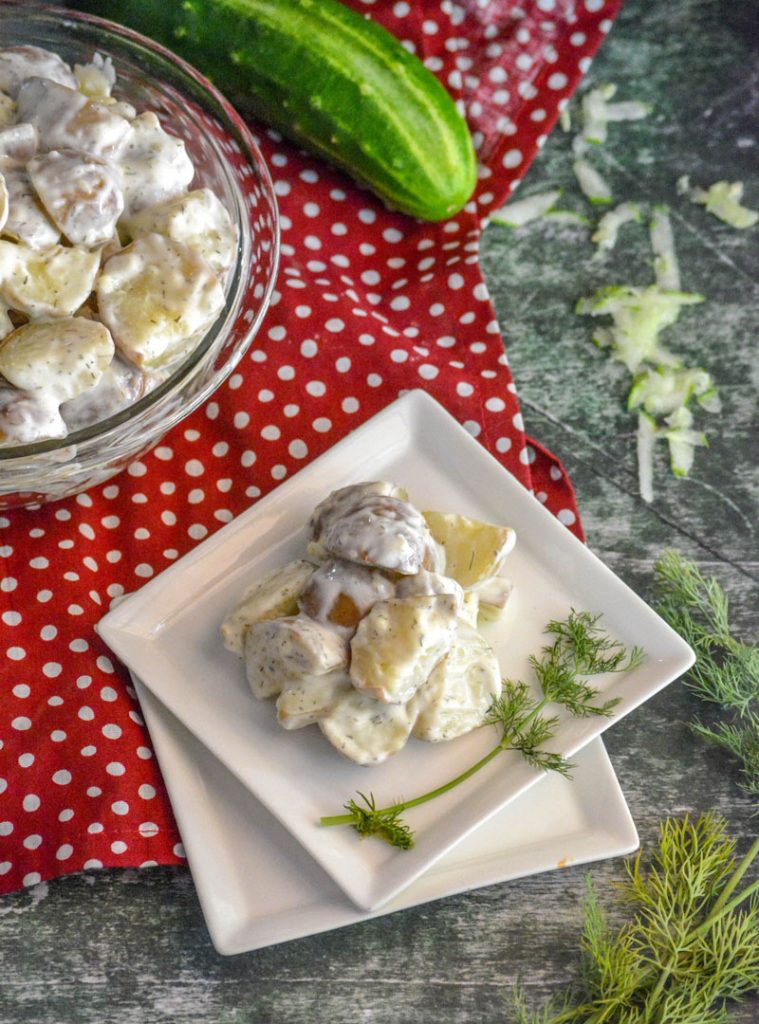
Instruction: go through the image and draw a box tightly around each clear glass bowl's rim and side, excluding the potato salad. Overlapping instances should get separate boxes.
[0,0,280,509]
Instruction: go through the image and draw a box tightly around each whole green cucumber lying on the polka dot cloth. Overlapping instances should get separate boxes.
[80,0,477,221]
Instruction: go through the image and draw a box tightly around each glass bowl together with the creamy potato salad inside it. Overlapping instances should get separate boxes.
[0,0,279,508]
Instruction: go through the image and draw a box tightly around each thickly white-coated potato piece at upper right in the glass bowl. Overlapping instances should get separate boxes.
[114,111,195,217]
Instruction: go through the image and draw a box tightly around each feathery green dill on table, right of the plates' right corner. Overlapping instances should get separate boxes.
[656,551,759,797]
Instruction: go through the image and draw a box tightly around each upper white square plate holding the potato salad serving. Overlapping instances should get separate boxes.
[98,391,693,910]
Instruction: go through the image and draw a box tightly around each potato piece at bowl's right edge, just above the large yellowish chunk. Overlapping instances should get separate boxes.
[122,188,238,273]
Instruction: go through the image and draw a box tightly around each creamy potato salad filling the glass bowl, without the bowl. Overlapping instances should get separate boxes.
[0,46,238,446]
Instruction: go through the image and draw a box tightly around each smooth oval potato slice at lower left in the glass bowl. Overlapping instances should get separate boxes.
[0,316,114,402]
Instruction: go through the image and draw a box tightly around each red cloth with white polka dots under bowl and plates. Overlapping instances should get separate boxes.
[0,0,619,892]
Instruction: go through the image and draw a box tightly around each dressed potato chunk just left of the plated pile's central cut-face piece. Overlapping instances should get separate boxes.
[243,615,348,699]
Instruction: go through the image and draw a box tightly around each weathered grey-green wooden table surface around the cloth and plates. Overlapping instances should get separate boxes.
[0,0,759,1024]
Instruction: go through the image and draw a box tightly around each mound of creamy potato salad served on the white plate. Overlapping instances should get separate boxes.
[221,481,516,765]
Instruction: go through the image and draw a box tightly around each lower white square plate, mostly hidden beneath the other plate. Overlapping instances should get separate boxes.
[134,677,638,955]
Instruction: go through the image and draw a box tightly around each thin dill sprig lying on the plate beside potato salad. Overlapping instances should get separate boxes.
[320,608,643,850]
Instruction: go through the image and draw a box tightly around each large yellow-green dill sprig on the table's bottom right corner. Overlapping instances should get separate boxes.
[514,814,759,1024]
